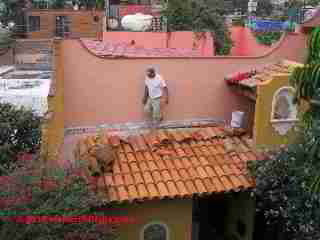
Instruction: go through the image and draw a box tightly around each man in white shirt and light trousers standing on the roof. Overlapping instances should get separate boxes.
[142,67,169,123]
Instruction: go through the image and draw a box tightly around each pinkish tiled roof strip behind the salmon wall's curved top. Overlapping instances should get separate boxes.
[80,39,202,58]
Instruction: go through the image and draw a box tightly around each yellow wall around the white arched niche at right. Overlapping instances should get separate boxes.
[255,71,301,147]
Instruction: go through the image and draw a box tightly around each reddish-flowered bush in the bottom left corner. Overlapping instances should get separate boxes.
[0,159,116,240]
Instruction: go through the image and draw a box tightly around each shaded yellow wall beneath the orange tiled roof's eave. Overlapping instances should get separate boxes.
[104,199,192,240]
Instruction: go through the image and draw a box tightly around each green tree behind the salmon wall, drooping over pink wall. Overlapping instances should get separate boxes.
[161,0,232,55]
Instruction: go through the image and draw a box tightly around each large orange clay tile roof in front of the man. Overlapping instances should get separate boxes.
[75,126,261,203]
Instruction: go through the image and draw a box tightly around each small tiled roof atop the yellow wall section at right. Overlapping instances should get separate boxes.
[225,60,292,88]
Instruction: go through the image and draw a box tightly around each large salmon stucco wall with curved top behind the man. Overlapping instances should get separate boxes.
[62,34,306,127]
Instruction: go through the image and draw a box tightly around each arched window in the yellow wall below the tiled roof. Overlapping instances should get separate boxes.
[141,223,169,240]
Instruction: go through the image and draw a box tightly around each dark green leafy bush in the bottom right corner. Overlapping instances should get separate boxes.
[251,142,320,240]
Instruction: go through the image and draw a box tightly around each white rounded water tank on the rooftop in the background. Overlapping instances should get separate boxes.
[121,13,153,32]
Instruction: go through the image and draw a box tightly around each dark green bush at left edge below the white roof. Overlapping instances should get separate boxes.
[0,103,41,174]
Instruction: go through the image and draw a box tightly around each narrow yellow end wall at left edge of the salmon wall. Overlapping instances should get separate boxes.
[41,40,64,167]
